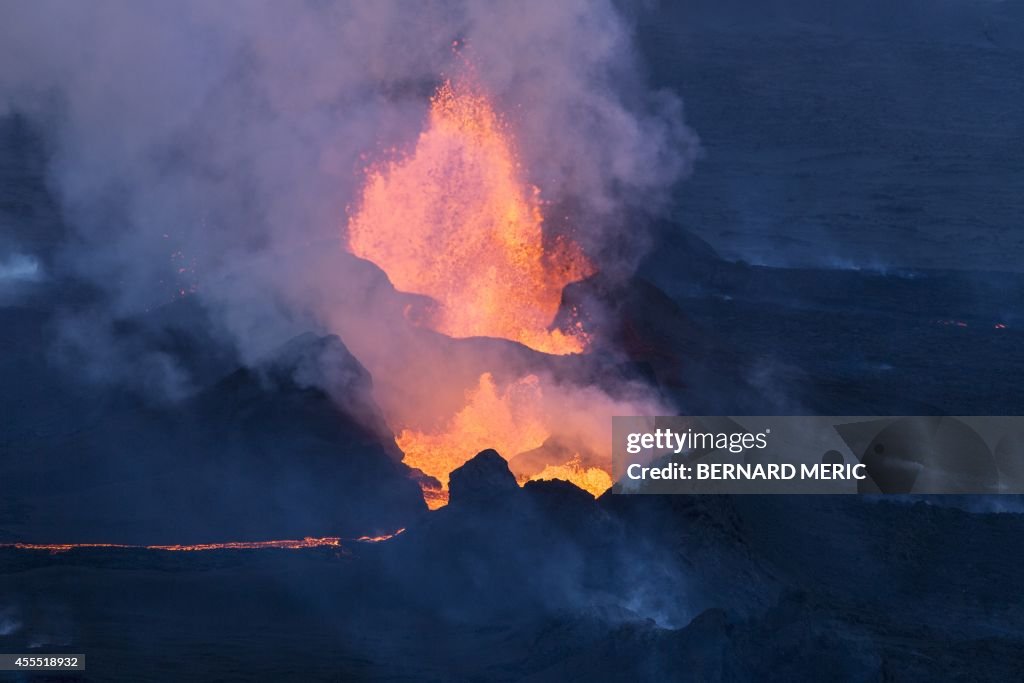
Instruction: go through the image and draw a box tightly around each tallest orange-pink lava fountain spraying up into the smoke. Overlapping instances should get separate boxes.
[348,81,592,356]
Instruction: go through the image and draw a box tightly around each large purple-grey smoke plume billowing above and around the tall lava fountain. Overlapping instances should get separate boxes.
[0,0,695,392]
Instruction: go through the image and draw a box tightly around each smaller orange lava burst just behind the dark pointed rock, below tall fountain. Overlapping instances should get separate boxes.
[395,373,549,509]
